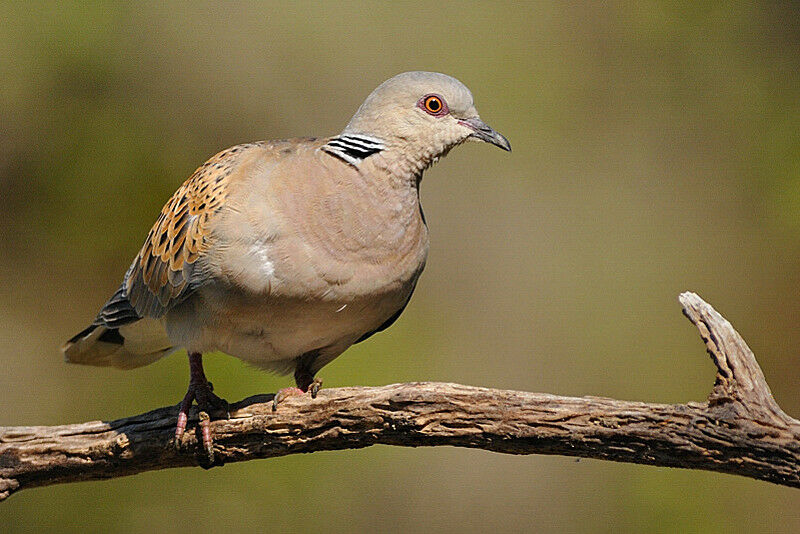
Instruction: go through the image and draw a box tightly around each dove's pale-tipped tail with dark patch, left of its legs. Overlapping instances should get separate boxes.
[61,319,174,369]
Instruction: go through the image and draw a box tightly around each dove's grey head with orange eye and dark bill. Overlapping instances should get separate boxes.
[342,72,511,175]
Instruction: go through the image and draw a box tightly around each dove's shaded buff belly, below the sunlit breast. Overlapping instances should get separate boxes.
[166,266,421,372]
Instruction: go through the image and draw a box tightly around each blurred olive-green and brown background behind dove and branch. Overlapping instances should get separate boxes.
[0,2,800,532]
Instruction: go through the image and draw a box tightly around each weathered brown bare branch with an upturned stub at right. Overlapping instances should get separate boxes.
[0,293,800,500]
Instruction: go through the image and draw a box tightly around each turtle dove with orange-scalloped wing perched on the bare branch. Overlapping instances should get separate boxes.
[62,71,511,459]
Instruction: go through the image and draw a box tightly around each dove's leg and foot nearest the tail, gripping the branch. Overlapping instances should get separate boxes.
[175,353,228,461]
